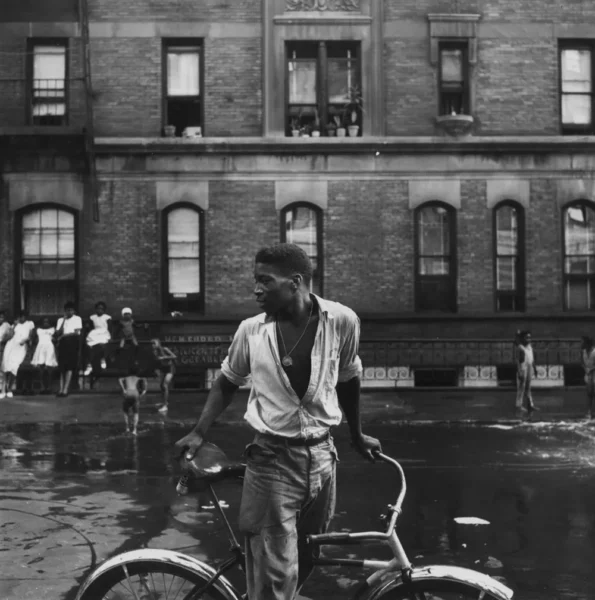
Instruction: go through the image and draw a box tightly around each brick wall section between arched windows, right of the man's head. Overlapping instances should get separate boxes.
[324,180,413,313]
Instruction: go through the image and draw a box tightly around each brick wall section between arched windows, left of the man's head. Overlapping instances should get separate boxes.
[205,181,280,315]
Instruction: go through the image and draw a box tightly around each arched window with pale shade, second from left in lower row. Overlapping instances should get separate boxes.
[164,204,204,312]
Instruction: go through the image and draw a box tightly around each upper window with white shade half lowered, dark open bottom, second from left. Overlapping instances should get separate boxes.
[164,41,202,136]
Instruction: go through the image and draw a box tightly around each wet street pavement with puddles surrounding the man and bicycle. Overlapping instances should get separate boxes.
[0,414,595,600]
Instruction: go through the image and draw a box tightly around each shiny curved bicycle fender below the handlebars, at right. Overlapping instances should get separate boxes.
[365,565,514,600]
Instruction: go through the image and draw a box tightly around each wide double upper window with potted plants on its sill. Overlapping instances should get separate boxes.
[286,41,363,135]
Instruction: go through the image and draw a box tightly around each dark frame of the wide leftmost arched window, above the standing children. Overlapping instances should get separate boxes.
[13,202,81,319]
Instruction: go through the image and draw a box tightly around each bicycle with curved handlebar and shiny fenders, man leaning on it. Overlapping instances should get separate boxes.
[75,443,513,600]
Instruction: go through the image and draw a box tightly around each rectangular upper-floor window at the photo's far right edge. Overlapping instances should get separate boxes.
[560,42,593,134]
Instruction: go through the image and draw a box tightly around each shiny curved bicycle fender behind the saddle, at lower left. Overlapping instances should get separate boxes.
[75,548,241,600]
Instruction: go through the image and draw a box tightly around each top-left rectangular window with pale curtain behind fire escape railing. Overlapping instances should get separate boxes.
[31,42,68,125]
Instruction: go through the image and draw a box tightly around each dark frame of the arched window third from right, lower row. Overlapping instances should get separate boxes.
[413,200,458,314]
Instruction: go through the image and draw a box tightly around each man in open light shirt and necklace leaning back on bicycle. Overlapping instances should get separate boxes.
[176,244,381,600]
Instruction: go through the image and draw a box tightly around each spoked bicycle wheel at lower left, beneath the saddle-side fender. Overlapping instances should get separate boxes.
[80,560,233,600]
